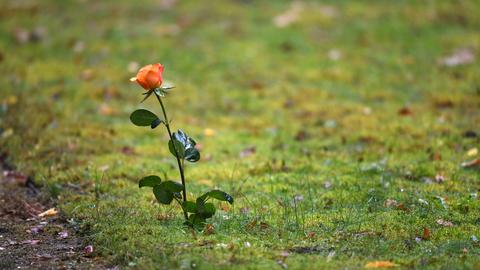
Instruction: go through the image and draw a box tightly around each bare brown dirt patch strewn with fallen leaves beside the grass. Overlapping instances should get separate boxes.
[0,154,107,269]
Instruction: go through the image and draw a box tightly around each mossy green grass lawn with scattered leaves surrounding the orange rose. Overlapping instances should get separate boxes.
[0,0,480,269]
